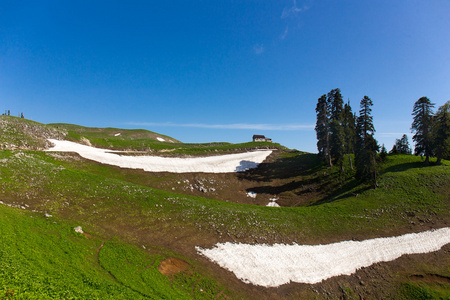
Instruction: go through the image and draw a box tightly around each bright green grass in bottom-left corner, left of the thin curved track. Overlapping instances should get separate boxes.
[0,206,139,299]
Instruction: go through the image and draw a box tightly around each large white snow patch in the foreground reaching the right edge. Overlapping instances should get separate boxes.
[197,227,450,287]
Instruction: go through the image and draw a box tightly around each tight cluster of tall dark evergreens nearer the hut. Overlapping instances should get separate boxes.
[315,89,380,184]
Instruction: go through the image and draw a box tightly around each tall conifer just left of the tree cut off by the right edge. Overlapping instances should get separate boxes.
[411,97,434,165]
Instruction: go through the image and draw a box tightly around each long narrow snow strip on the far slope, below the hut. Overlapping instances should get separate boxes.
[47,139,272,173]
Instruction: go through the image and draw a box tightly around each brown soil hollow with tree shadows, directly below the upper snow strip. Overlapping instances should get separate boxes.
[74,150,326,207]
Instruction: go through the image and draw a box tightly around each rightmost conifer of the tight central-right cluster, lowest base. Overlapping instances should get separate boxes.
[355,96,380,187]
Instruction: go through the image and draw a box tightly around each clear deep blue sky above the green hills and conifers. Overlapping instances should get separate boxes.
[0,0,450,152]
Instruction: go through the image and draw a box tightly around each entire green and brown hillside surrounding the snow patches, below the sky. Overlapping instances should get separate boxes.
[0,117,450,299]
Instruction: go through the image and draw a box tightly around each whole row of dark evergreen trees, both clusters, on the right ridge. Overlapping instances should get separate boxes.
[315,89,450,186]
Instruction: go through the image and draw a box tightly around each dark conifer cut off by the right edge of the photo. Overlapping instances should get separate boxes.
[433,100,450,164]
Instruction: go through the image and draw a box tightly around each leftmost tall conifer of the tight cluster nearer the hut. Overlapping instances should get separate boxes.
[315,94,332,166]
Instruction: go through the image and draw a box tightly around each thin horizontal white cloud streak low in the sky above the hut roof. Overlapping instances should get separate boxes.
[127,122,314,131]
